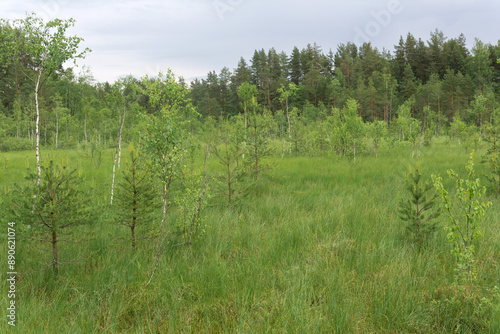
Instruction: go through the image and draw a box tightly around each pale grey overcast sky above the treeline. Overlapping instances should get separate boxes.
[0,0,500,82]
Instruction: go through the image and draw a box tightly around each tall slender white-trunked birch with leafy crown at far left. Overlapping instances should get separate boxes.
[0,13,90,184]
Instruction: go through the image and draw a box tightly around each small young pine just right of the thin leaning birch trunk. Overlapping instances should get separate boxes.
[116,143,157,249]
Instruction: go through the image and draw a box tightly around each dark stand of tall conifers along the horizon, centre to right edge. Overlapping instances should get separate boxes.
[191,30,500,122]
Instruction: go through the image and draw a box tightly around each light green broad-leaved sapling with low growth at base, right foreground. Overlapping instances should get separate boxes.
[431,152,500,333]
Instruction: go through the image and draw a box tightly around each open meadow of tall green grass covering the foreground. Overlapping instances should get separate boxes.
[0,141,500,334]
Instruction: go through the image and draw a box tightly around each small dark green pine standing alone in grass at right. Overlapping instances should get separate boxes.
[399,166,440,249]
